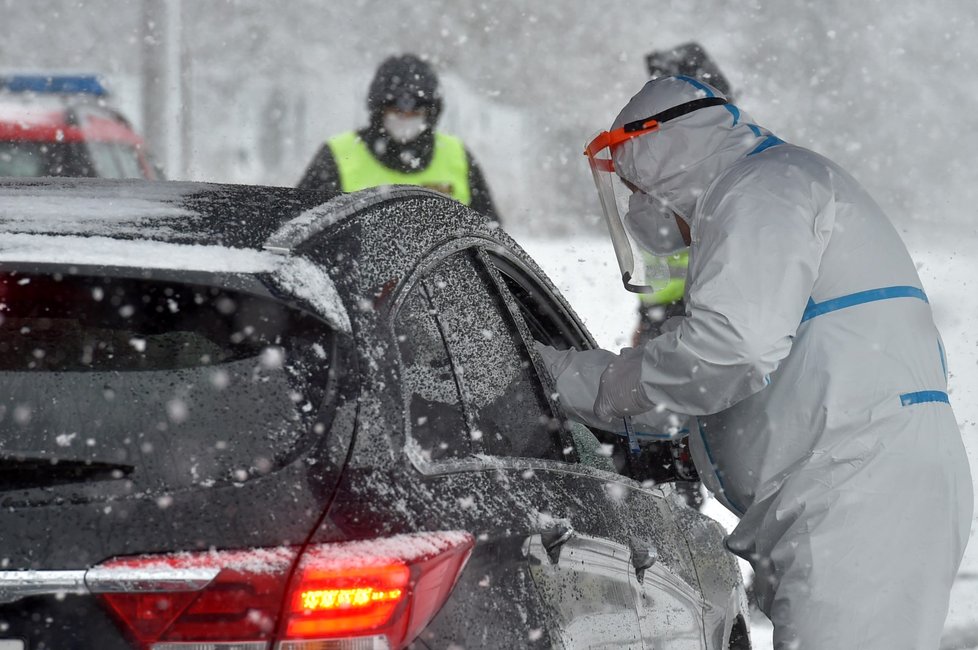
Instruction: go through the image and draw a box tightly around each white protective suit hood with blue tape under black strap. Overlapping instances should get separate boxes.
[612,75,780,220]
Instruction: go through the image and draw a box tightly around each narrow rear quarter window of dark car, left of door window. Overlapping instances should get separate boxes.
[394,282,476,461]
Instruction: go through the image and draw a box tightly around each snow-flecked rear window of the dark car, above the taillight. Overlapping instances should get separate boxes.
[0,272,335,498]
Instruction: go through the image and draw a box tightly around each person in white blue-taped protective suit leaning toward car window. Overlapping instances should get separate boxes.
[539,76,973,650]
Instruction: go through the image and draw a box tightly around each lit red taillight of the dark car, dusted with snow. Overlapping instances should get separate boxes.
[93,532,473,650]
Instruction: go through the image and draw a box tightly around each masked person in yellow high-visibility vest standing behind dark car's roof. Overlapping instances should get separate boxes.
[298,54,499,221]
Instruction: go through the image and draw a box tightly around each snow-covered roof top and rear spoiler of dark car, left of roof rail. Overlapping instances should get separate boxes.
[0,179,351,332]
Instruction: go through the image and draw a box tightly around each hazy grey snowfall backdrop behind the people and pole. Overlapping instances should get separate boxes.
[0,0,978,232]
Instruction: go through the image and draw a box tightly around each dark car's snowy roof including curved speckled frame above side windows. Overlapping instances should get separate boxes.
[0,178,548,340]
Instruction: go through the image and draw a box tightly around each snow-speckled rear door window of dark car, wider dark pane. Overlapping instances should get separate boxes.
[425,250,565,460]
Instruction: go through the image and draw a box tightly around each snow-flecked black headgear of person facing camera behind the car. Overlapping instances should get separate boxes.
[367,54,441,124]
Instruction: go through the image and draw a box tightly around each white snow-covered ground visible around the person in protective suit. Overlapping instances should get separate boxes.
[517,222,978,650]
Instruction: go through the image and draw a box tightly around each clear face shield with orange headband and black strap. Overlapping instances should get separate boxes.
[584,97,727,293]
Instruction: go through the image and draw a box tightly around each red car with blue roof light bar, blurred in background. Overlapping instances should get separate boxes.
[0,75,161,180]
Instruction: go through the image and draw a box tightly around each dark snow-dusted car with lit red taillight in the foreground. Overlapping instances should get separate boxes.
[0,180,750,650]
